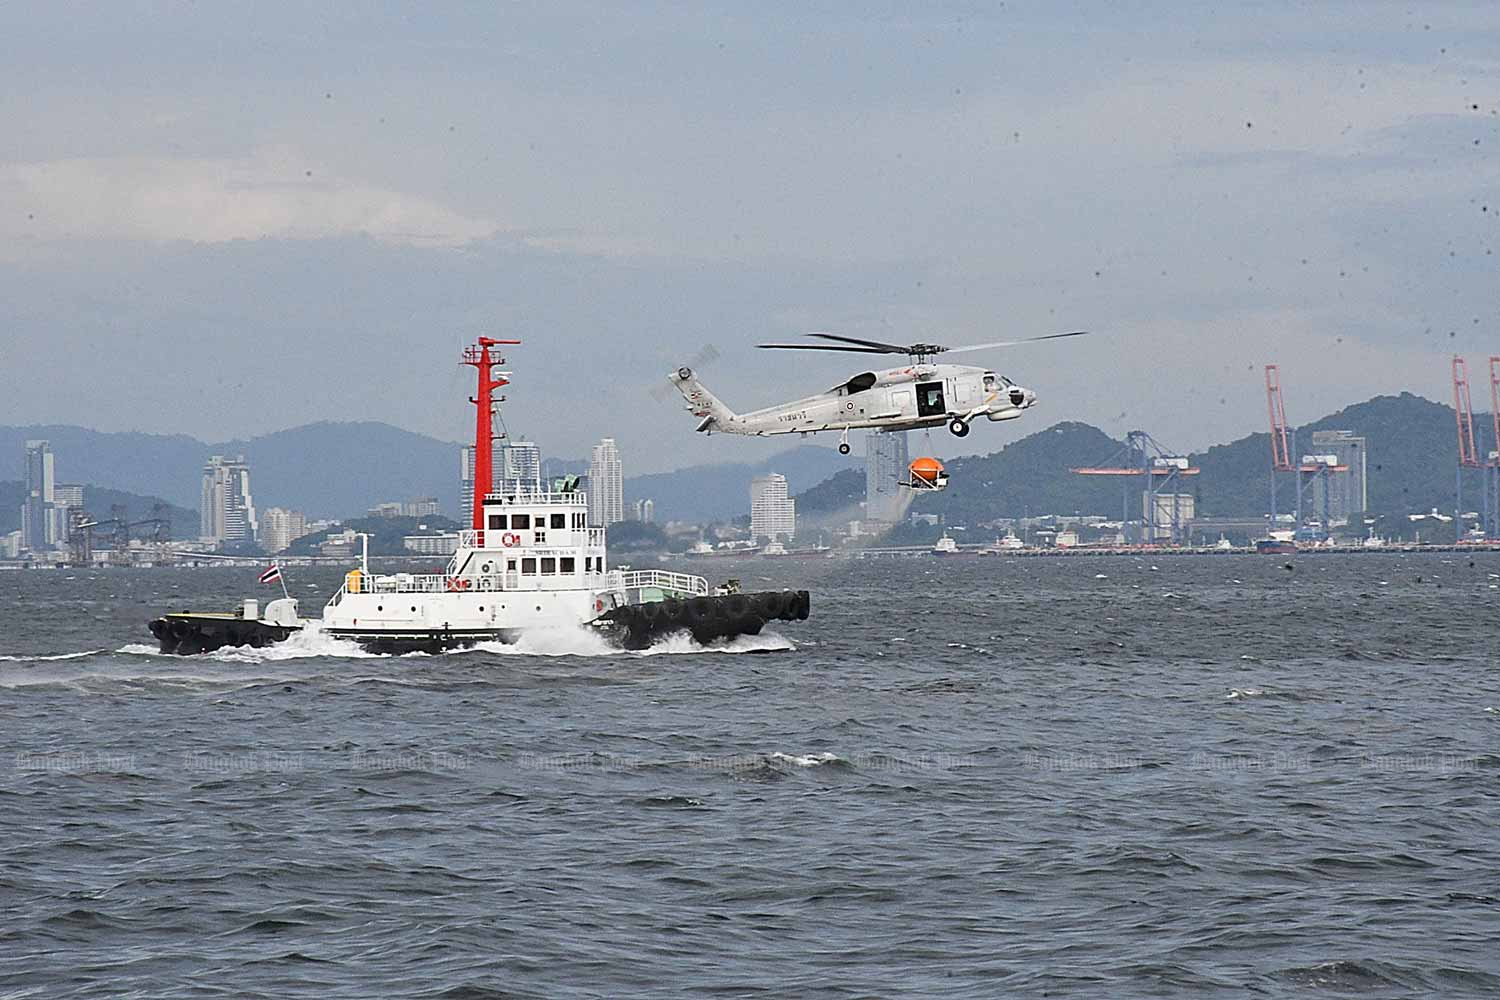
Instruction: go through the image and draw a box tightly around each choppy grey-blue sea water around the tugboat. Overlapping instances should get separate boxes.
[0,555,1500,999]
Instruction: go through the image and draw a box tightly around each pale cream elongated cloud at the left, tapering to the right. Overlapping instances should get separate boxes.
[0,150,500,247]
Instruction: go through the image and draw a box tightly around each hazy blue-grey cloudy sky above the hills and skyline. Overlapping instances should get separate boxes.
[0,0,1500,474]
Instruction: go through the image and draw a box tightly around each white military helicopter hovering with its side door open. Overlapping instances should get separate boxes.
[668,330,1088,454]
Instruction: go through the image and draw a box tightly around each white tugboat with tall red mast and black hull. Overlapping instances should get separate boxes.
[150,344,810,654]
